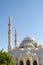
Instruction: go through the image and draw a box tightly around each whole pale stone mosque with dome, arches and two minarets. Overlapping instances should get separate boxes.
[8,17,43,65]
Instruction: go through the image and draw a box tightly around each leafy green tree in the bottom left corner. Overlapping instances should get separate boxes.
[0,50,14,65]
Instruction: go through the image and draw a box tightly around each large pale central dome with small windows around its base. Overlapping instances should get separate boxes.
[20,37,37,47]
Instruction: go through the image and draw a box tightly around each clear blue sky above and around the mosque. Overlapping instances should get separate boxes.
[0,0,43,50]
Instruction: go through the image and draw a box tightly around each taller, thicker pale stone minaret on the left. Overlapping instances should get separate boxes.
[8,16,12,52]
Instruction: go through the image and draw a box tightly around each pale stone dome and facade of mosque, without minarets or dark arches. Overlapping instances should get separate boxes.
[10,37,43,65]
